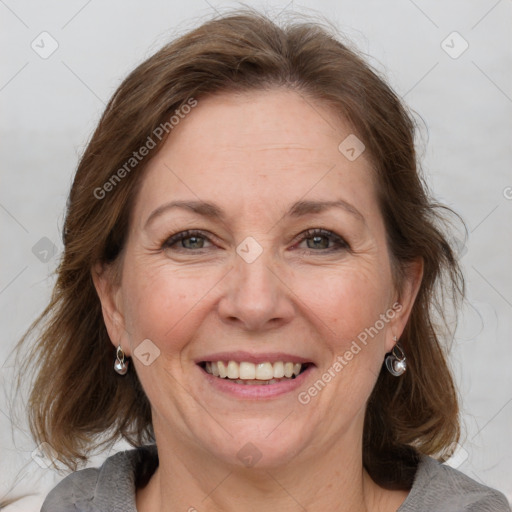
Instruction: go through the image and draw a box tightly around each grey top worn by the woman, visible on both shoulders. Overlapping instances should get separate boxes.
[41,445,511,512]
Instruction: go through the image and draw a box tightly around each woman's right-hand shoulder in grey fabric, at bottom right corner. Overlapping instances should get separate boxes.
[398,456,511,512]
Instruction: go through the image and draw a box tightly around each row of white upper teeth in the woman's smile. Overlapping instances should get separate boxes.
[205,361,302,380]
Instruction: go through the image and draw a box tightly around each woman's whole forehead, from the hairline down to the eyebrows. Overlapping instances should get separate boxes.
[130,89,374,227]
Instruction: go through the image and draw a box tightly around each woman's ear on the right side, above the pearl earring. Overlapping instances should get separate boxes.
[386,258,423,352]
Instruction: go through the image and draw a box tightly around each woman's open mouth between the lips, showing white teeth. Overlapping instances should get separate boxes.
[198,360,313,386]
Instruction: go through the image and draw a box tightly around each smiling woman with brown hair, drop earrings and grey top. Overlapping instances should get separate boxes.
[18,5,509,512]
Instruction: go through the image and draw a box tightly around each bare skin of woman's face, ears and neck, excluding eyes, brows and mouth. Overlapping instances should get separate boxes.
[94,90,421,512]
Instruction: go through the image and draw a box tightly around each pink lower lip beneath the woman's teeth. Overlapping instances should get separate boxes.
[198,365,314,400]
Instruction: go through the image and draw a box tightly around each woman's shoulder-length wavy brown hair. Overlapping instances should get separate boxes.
[16,9,464,489]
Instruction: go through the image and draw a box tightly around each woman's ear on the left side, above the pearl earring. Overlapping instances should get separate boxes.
[91,263,130,356]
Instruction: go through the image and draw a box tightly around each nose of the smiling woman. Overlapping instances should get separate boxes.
[218,243,295,332]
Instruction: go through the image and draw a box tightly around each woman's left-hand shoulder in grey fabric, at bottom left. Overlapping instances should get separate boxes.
[41,445,158,512]
